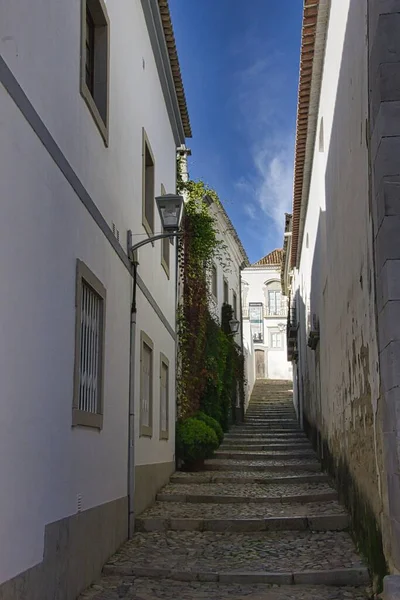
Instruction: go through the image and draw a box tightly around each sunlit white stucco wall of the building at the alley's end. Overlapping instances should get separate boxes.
[242,266,292,379]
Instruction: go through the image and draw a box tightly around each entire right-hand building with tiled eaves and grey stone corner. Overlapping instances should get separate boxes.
[283,0,400,587]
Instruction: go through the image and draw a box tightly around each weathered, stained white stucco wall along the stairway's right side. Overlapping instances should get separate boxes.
[293,0,381,528]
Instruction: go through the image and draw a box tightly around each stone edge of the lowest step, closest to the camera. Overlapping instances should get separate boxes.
[103,565,370,587]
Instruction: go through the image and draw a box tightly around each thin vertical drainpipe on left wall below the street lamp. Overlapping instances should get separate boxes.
[128,255,138,539]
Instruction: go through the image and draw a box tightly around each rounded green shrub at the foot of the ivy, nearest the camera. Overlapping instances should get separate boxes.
[176,417,219,465]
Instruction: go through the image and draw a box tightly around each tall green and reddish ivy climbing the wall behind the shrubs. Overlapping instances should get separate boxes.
[177,163,244,431]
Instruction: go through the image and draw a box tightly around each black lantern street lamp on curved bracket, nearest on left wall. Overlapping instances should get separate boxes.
[128,194,184,262]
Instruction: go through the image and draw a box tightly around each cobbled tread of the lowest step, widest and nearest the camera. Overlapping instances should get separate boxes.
[104,531,364,584]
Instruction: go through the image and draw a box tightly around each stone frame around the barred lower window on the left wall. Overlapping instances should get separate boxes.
[72,259,106,429]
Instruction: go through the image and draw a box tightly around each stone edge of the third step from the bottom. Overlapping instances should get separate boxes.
[156,490,338,505]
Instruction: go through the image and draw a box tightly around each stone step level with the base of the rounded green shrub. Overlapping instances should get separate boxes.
[204,458,321,472]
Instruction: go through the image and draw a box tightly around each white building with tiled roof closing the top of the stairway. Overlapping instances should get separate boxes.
[242,249,292,382]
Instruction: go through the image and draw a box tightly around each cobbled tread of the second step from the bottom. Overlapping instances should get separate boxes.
[140,500,347,519]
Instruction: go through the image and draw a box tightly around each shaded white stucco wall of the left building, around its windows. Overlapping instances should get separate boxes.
[0,0,176,583]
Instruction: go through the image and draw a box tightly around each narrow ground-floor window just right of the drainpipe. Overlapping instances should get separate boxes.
[140,331,153,437]
